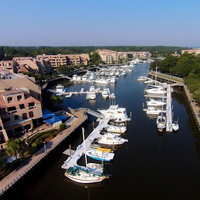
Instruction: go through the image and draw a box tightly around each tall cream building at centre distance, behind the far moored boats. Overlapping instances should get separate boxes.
[97,49,118,64]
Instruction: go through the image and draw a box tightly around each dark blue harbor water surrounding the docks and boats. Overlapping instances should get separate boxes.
[2,64,200,200]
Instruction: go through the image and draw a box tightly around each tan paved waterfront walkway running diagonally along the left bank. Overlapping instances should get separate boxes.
[0,110,87,195]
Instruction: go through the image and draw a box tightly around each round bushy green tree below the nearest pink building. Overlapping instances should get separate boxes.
[6,138,26,159]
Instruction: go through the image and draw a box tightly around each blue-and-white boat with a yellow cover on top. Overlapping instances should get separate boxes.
[86,148,114,161]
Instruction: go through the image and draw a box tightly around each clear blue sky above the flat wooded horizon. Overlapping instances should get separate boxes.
[0,0,200,46]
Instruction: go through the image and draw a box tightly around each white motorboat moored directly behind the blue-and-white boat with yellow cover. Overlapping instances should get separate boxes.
[98,133,128,145]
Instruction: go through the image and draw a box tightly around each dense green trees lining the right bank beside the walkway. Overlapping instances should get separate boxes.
[150,53,200,105]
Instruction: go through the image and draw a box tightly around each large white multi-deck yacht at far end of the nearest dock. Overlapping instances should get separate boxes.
[97,105,128,119]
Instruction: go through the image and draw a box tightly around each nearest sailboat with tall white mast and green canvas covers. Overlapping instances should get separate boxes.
[65,128,108,183]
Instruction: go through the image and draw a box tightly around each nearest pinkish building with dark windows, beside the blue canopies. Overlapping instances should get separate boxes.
[0,88,42,142]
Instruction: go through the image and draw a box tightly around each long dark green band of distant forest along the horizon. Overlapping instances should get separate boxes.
[0,46,187,60]
